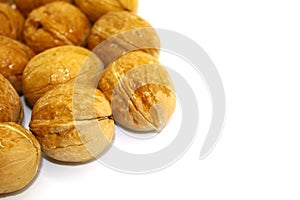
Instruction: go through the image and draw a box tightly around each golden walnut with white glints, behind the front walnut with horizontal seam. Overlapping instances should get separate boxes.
[23,45,103,106]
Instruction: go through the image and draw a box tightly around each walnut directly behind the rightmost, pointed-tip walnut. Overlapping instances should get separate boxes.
[88,11,160,65]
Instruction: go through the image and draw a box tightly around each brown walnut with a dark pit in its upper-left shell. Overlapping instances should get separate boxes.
[24,1,91,53]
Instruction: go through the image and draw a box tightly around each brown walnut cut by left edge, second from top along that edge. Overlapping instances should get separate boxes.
[0,36,35,94]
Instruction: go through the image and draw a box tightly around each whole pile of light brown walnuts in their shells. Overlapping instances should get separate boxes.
[0,0,176,194]
